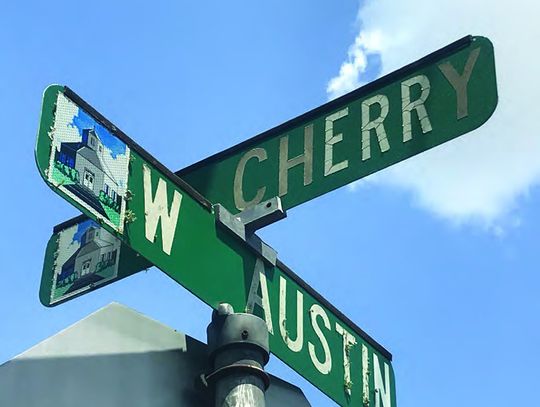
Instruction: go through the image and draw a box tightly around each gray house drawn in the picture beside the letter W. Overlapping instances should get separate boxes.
[55,129,122,213]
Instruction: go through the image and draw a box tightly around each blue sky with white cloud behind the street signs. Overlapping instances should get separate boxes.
[0,0,540,407]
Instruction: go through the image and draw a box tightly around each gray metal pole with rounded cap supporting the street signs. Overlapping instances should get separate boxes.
[205,303,270,407]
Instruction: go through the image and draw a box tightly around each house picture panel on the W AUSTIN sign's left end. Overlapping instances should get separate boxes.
[48,93,130,232]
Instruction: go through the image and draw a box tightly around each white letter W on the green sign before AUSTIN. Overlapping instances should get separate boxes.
[143,164,182,255]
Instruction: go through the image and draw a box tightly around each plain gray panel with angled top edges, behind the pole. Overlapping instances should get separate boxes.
[0,303,310,407]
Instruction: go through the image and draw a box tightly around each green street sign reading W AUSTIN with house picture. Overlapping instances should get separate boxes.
[36,85,396,407]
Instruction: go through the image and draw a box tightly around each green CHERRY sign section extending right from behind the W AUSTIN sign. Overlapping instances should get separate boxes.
[178,36,497,213]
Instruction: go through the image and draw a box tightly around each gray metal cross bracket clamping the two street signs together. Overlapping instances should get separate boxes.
[213,196,287,266]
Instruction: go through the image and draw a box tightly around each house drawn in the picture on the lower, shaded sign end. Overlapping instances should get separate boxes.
[56,226,120,286]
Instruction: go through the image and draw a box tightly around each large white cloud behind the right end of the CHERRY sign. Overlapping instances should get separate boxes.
[327,0,540,230]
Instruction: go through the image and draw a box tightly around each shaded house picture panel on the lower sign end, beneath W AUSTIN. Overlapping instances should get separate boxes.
[51,220,121,304]
